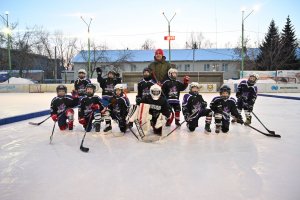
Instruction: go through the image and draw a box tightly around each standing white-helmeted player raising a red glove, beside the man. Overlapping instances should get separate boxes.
[162,68,190,126]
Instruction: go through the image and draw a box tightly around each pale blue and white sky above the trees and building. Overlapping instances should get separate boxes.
[0,0,300,49]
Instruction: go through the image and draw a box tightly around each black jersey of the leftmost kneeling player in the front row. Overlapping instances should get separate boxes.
[50,95,79,115]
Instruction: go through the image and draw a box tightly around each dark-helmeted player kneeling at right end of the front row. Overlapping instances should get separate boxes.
[210,85,244,133]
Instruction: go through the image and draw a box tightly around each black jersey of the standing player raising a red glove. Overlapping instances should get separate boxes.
[162,79,188,103]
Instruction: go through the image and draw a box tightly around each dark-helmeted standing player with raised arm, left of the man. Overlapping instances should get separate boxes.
[96,67,122,132]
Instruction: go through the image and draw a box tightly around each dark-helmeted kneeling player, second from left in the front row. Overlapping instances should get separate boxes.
[78,83,104,132]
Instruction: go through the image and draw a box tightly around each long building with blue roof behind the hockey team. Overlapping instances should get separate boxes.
[72,49,240,79]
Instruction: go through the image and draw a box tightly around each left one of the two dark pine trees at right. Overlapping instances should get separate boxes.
[257,20,280,70]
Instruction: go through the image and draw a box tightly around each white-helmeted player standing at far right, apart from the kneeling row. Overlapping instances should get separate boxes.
[231,73,259,125]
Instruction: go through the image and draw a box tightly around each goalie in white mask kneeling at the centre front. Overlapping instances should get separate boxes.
[141,84,171,135]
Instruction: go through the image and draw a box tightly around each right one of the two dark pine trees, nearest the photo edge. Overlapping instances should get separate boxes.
[280,16,298,69]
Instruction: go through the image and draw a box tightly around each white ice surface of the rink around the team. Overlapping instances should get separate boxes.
[0,93,300,200]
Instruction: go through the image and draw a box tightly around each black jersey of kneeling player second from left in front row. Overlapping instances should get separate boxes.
[78,95,104,118]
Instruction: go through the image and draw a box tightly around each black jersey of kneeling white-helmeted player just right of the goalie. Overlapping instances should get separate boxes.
[182,93,207,118]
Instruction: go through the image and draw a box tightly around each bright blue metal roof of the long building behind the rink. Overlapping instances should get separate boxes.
[72,48,300,63]
